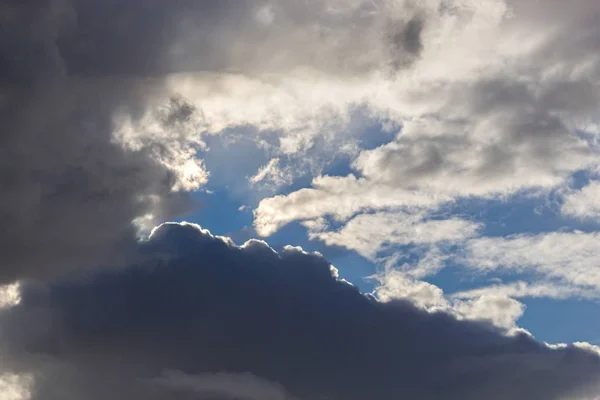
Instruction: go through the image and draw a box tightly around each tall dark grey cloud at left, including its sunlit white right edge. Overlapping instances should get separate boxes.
[0,0,213,283]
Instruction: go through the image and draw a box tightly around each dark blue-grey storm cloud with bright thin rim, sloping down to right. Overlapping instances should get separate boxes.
[0,224,600,400]
